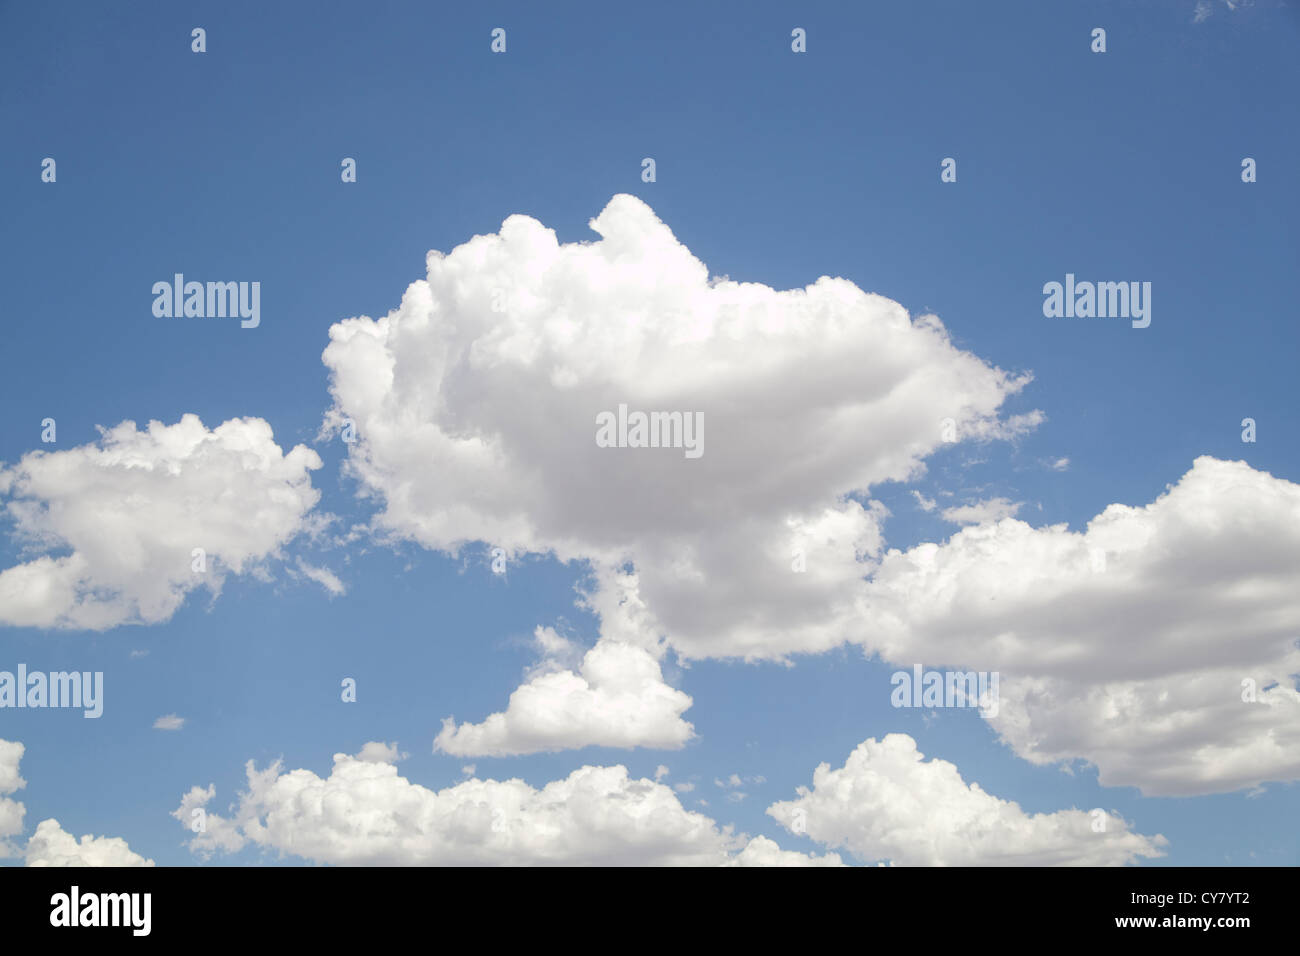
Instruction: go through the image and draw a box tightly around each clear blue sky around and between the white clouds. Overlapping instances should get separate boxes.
[0,0,1300,865]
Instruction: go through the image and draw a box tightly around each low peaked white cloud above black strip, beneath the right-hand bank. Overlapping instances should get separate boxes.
[767,734,1166,866]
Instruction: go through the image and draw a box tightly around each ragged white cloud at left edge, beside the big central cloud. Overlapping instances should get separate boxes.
[0,415,321,631]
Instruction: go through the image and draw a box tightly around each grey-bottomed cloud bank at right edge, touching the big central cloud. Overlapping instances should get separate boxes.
[862,458,1300,795]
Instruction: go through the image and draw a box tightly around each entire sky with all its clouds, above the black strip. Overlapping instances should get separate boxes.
[0,0,1300,866]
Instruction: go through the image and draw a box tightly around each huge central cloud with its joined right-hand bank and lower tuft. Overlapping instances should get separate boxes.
[324,196,1300,793]
